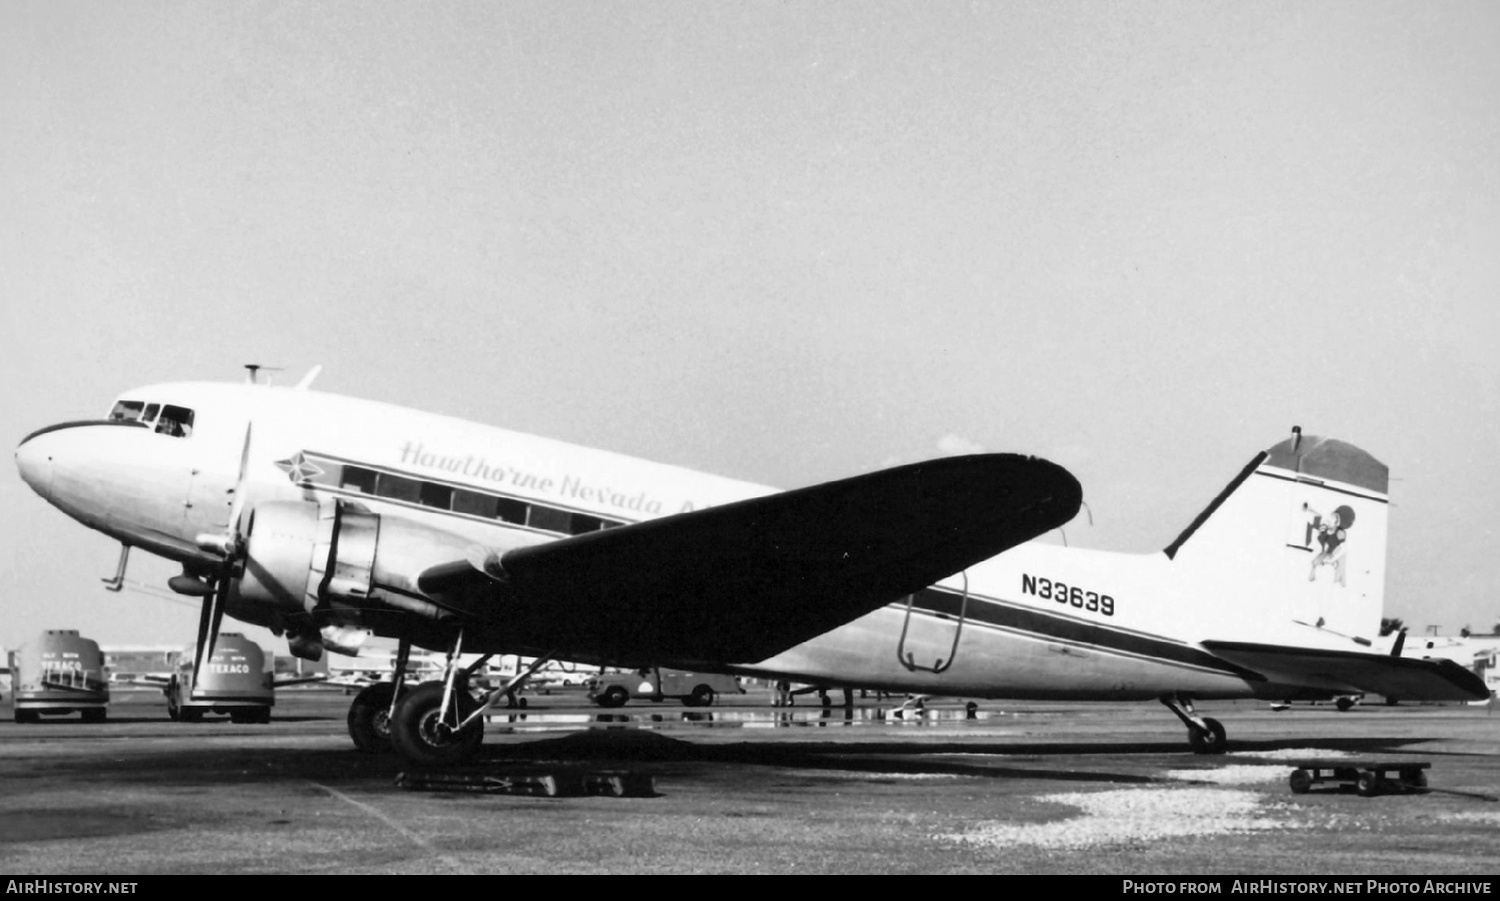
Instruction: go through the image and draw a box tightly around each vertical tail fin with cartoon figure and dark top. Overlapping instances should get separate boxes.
[1166,429,1389,648]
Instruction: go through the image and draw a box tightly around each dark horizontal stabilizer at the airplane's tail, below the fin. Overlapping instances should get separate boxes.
[1203,642,1490,700]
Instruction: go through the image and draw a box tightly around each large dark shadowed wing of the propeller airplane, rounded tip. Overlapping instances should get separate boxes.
[419,454,1082,663]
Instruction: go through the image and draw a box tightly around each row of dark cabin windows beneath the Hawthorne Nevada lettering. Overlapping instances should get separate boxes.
[312,460,624,535]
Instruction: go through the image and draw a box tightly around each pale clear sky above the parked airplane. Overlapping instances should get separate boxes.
[0,0,1500,646]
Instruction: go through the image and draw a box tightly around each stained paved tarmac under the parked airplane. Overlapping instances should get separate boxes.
[0,688,1500,889]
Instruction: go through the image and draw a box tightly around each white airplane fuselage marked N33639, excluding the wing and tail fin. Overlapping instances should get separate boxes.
[17,384,1386,699]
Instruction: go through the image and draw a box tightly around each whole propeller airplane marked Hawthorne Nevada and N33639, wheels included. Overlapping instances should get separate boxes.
[15,373,1485,765]
